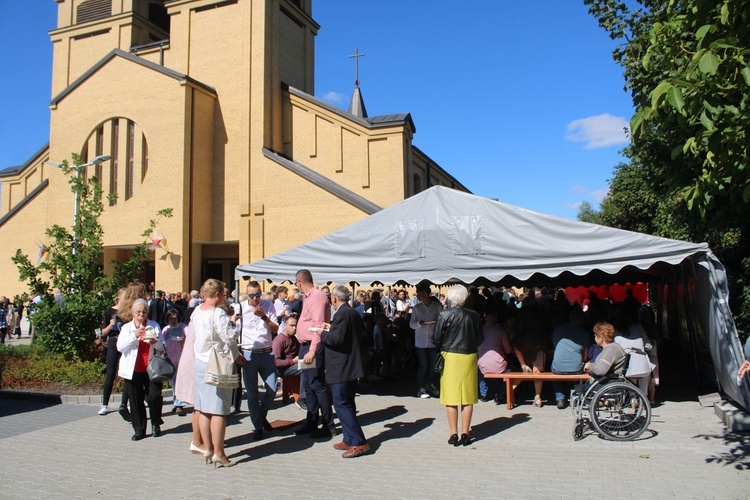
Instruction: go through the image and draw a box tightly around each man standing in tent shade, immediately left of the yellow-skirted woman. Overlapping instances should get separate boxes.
[409,285,442,399]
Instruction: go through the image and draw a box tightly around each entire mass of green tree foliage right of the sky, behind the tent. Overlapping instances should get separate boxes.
[579,0,750,336]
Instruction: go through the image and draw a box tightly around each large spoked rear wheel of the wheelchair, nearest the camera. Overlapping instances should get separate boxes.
[589,382,651,441]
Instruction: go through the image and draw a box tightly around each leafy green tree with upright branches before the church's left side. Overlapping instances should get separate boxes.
[12,154,172,359]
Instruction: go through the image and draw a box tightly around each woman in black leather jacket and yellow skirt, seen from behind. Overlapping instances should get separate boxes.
[432,285,484,446]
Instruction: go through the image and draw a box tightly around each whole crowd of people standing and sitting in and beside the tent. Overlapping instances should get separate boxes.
[95,278,658,460]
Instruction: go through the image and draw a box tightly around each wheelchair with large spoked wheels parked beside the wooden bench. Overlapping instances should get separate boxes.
[570,375,651,441]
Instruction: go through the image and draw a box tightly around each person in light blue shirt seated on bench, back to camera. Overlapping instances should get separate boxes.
[552,304,591,410]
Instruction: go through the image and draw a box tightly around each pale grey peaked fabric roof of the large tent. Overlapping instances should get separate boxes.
[235,186,710,285]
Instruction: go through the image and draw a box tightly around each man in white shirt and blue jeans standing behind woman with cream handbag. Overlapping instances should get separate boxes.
[240,281,279,440]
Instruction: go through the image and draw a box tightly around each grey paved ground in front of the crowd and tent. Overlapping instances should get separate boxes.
[0,374,750,499]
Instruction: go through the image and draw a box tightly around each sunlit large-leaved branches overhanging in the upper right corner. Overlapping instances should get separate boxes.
[584,0,750,218]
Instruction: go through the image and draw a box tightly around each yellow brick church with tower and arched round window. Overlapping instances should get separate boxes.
[0,0,466,296]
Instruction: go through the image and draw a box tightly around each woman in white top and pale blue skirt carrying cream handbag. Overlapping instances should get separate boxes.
[190,279,245,468]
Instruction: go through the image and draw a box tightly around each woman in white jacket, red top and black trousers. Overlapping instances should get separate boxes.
[117,299,164,441]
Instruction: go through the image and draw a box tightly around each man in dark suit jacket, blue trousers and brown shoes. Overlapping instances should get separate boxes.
[318,286,370,458]
